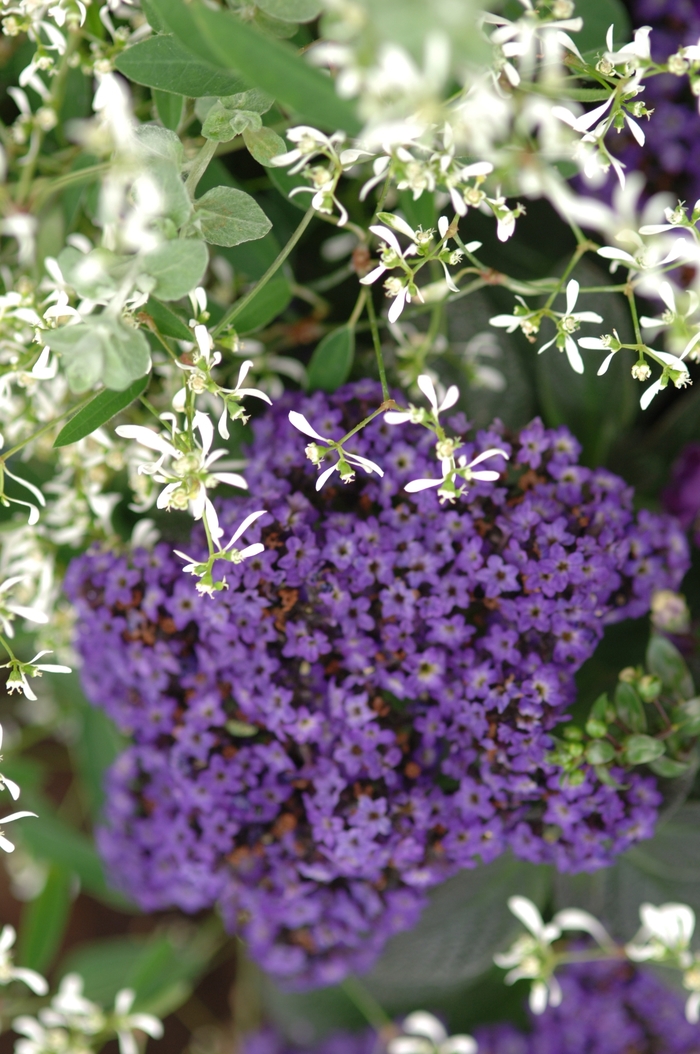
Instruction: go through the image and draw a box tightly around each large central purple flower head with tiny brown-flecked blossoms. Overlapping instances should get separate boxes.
[66,382,687,985]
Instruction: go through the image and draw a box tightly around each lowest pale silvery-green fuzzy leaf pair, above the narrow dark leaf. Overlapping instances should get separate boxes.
[44,313,151,392]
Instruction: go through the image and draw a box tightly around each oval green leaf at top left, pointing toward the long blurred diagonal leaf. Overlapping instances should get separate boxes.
[114,34,241,99]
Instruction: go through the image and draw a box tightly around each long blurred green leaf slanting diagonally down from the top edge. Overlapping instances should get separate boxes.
[148,0,361,135]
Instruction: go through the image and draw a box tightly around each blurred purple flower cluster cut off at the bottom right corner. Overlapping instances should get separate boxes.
[476,962,700,1054]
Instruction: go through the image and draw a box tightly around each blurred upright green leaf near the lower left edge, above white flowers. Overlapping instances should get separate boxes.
[17,864,73,973]
